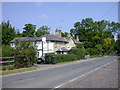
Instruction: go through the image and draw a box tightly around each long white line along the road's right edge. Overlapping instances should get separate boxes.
[53,60,115,89]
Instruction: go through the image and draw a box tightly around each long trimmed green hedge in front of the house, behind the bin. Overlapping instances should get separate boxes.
[45,54,77,64]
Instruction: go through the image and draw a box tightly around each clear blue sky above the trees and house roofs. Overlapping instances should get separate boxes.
[2,2,118,39]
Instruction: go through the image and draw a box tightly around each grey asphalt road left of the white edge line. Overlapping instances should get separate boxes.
[2,56,117,88]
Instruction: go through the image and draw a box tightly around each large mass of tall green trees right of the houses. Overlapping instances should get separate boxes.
[70,18,120,55]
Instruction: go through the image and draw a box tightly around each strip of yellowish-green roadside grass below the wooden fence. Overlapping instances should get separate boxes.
[0,67,40,75]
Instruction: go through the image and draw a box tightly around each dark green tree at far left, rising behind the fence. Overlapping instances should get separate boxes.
[0,20,16,45]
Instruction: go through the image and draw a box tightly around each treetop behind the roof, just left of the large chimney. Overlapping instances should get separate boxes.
[35,26,50,37]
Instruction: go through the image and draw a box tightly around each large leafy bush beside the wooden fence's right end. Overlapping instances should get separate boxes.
[14,40,37,68]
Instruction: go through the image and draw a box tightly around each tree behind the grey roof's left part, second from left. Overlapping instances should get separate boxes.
[22,24,36,37]
